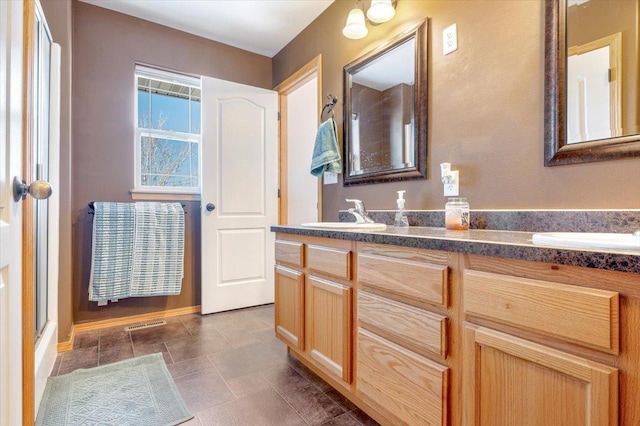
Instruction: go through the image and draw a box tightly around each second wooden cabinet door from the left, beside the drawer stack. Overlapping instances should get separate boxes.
[308,276,352,383]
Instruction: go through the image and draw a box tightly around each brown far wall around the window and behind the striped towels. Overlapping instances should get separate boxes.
[69,1,272,326]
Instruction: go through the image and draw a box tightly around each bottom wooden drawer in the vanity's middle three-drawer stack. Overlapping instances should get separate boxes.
[356,328,449,425]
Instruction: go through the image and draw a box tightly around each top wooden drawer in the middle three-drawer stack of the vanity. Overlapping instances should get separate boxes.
[358,254,448,306]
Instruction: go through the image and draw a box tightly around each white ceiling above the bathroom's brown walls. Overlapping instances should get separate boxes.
[81,0,334,58]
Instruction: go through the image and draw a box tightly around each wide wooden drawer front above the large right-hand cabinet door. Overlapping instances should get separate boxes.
[463,270,620,353]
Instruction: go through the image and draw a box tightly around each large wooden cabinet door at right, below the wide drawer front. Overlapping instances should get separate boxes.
[463,324,618,426]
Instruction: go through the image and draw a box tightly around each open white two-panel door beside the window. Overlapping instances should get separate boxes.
[201,77,278,314]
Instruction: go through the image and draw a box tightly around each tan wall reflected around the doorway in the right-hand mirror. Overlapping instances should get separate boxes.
[567,0,640,135]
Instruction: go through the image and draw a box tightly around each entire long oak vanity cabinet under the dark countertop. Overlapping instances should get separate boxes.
[275,234,640,426]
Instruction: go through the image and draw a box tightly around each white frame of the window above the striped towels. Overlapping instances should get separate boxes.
[131,64,202,200]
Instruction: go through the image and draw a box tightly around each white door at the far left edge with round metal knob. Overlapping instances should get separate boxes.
[0,0,25,425]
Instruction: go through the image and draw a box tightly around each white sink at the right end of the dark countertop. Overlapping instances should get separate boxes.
[532,232,640,250]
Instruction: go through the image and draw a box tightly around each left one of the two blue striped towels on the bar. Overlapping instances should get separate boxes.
[89,201,135,302]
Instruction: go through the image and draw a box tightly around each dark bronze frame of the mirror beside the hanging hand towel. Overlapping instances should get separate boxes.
[343,19,427,186]
